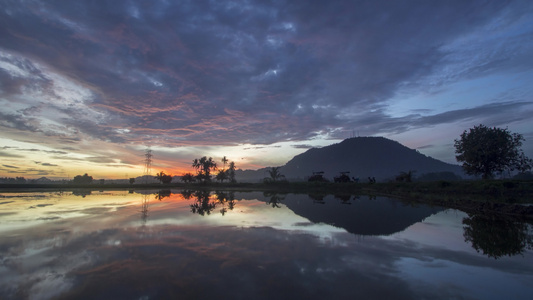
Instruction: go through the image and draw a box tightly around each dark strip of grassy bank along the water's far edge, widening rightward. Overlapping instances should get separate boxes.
[0,180,533,218]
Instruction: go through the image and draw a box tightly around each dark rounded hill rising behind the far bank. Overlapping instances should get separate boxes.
[236,137,464,182]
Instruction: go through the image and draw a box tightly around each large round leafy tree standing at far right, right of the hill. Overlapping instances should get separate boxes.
[454,124,533,179]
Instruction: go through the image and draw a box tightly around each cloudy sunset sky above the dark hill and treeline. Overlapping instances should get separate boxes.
[0,0,533,179]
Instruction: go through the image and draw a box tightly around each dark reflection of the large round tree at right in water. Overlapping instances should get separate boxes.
[463,215,533,259]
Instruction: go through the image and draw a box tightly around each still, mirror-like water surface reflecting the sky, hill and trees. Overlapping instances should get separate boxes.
[0,190,533,299]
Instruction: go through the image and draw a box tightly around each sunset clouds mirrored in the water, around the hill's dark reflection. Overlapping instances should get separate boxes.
[0,191,533,299]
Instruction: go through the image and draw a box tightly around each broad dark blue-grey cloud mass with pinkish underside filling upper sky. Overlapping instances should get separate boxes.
[0,1,533,146]
